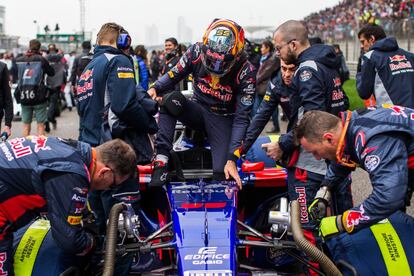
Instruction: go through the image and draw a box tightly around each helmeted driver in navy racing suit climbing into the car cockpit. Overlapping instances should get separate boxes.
[148,19,256,186]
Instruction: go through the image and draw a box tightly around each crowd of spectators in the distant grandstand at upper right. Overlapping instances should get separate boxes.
[303,0,414,42]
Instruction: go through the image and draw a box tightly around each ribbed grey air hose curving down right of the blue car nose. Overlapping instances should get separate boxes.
[290,200,342,276]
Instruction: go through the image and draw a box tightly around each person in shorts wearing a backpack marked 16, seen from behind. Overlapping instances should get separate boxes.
[14,39,55,136]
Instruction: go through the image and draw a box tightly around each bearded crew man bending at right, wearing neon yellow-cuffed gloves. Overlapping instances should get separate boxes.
[296,106,414,237]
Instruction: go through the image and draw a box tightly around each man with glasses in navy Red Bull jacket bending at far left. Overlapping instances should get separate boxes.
[0,136,136,275]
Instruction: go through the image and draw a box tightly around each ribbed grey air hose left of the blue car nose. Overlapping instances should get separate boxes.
[103,203,126,276]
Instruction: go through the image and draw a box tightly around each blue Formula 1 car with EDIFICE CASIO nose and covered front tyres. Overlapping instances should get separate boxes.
[14,113,414,276]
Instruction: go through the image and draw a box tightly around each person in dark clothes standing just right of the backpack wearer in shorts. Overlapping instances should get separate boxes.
[45,44,67,132]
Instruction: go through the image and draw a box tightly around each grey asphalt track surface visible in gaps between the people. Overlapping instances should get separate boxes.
[12,109,414,216]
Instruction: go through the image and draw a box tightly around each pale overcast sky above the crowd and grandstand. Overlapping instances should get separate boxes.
[0,0,339,45]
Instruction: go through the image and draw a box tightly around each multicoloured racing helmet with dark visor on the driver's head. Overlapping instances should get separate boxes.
[201,19,244,77]
